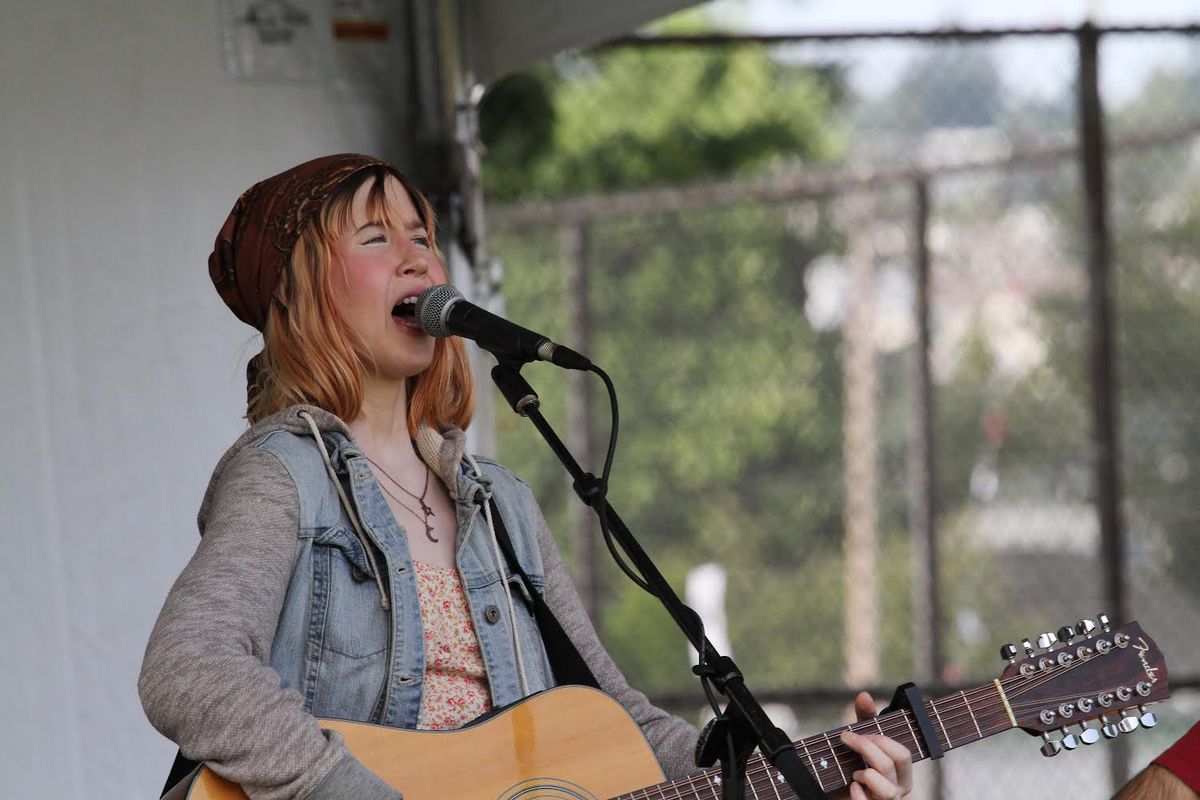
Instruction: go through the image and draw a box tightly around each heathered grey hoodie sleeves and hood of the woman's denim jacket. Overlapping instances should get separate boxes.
[138,407,697,800]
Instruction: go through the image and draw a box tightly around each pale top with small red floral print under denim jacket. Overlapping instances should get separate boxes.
[413,561,492,730]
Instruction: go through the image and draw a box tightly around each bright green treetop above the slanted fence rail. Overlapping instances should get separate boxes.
[480,14,836,200]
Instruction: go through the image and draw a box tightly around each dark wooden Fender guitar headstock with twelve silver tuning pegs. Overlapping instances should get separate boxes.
[1000,614,1171,756]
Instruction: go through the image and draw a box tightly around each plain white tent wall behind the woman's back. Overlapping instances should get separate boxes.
[0,0,406,798]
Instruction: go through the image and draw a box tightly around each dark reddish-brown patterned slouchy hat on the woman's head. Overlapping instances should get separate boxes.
[209,154,400,330]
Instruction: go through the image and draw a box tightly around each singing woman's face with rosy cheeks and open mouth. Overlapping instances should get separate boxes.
[330,175,446,380]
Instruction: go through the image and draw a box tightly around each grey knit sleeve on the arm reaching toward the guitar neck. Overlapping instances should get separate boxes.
[538,512,700,780]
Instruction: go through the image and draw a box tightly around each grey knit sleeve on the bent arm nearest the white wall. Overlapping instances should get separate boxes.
[138,447,400,800]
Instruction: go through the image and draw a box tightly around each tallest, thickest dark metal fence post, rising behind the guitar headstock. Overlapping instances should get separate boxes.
[1079,23,1129,788]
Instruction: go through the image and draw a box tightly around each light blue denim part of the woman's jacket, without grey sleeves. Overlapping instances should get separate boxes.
[250,412,553,728]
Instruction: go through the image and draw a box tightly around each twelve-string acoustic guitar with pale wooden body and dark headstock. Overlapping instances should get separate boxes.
[167,618,1170,800]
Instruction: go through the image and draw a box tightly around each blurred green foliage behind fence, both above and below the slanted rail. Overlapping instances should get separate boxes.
[481,10,864,691]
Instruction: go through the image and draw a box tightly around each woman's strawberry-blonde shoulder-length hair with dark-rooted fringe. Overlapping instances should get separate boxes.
[246,164,475,435]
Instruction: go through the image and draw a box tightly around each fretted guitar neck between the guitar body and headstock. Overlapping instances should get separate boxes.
[613,681,1018,800]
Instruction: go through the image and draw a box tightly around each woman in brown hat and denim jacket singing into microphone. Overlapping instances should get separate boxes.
[138,155,911,800]
